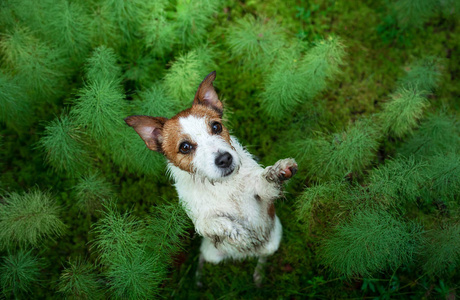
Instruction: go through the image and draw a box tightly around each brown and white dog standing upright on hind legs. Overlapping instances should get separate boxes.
[125,71,298,286]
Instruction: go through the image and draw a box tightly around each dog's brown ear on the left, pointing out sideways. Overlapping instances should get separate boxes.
[125,116,168,152]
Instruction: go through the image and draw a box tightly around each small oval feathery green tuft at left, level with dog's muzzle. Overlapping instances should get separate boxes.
[39,115,91,176]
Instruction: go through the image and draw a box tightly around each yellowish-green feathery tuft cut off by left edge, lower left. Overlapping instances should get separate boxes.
[0,189,65,249]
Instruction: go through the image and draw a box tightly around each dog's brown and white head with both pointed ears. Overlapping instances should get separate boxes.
[125,71,240,181]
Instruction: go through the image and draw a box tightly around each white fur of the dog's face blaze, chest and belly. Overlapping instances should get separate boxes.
[168,131,282,263]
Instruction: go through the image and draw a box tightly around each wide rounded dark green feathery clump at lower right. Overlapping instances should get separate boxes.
[320,211,421,278]
